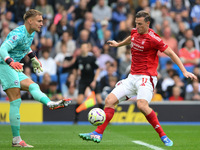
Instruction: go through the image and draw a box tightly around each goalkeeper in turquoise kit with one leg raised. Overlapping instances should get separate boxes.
[0,9,71,147]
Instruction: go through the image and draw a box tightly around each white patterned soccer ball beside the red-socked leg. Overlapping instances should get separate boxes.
[88,108,106,126]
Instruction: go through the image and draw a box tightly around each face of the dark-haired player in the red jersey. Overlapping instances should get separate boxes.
[135,17,150,34]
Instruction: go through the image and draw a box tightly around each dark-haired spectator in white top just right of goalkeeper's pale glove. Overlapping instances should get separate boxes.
[37,49,57,76]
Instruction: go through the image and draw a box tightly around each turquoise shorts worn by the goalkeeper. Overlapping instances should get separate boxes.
[0,64,28,91]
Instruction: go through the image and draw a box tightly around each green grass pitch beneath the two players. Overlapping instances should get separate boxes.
[0,125,200,150]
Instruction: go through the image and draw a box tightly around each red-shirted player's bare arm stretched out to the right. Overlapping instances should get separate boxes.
[164,47,197,80]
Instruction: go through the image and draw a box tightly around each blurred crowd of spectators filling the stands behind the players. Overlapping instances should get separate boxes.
[0,0,200,101]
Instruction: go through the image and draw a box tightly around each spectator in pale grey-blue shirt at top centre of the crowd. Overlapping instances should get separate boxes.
[92,0,112,22]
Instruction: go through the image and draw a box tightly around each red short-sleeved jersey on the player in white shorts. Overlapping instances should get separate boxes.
[130,28,168,76]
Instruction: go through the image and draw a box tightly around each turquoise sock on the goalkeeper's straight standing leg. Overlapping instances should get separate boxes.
[9,98,21,137]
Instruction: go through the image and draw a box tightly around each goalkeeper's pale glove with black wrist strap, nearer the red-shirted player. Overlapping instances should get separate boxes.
[28,52,43,73]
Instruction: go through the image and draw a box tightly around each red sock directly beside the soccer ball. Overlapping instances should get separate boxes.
[95,107,115,134]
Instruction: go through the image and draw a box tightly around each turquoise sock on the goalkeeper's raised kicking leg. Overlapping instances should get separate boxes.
[29,83,51,105]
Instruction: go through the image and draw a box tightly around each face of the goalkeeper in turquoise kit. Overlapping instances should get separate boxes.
[30,15,43,32]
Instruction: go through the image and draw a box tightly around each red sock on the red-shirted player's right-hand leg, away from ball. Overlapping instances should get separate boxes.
[146,110,166,137]
